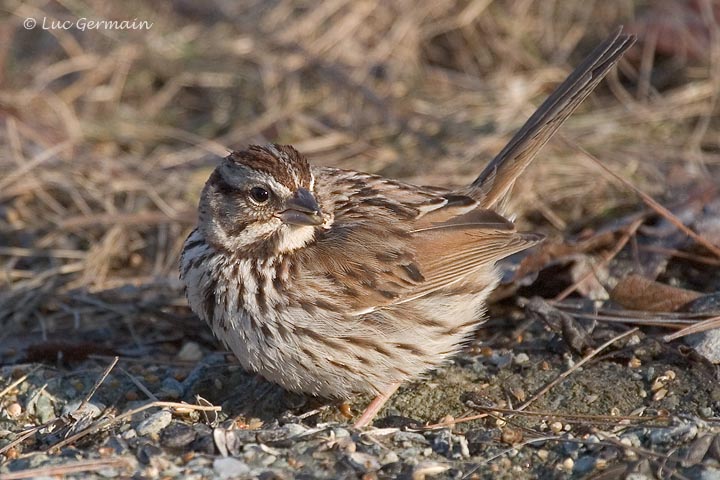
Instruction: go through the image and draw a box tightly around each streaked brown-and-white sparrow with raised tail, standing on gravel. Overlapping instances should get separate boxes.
[180,30,634,426]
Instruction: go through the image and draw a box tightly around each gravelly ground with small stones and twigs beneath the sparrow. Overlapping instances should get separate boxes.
[0,298,720,479]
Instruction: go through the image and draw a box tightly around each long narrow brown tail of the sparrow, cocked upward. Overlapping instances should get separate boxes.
[469,28,635,208]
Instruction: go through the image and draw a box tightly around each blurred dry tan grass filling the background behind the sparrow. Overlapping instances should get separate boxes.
[0,0,720,338]
